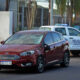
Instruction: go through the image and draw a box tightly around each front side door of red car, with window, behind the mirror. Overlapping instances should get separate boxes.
[44,32,54,63]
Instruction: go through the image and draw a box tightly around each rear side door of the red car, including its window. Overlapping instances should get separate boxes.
[52,32,64,61]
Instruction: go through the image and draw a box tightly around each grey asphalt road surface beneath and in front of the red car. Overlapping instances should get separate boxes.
[0,57,80,80]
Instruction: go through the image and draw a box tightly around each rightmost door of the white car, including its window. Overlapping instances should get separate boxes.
[67,28,80,50]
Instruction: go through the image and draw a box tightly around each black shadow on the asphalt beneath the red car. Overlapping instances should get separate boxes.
[0,65,69,75]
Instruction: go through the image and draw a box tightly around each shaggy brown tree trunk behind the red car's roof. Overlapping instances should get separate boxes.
[26,0,37,30]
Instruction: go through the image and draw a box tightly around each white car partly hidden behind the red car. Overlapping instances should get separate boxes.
[40,26,80,56]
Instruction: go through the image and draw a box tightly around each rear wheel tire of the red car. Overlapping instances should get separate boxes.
[60,52,70,67]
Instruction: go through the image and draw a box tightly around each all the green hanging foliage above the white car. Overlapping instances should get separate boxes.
[56,0,80,25]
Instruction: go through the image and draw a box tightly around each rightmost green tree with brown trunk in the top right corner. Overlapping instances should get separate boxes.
[68,0,80,26]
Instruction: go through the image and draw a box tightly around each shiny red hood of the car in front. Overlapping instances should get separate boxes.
[0,45,39,53]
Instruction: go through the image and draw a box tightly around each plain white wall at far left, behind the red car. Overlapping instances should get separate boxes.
[0,11,13,41]
